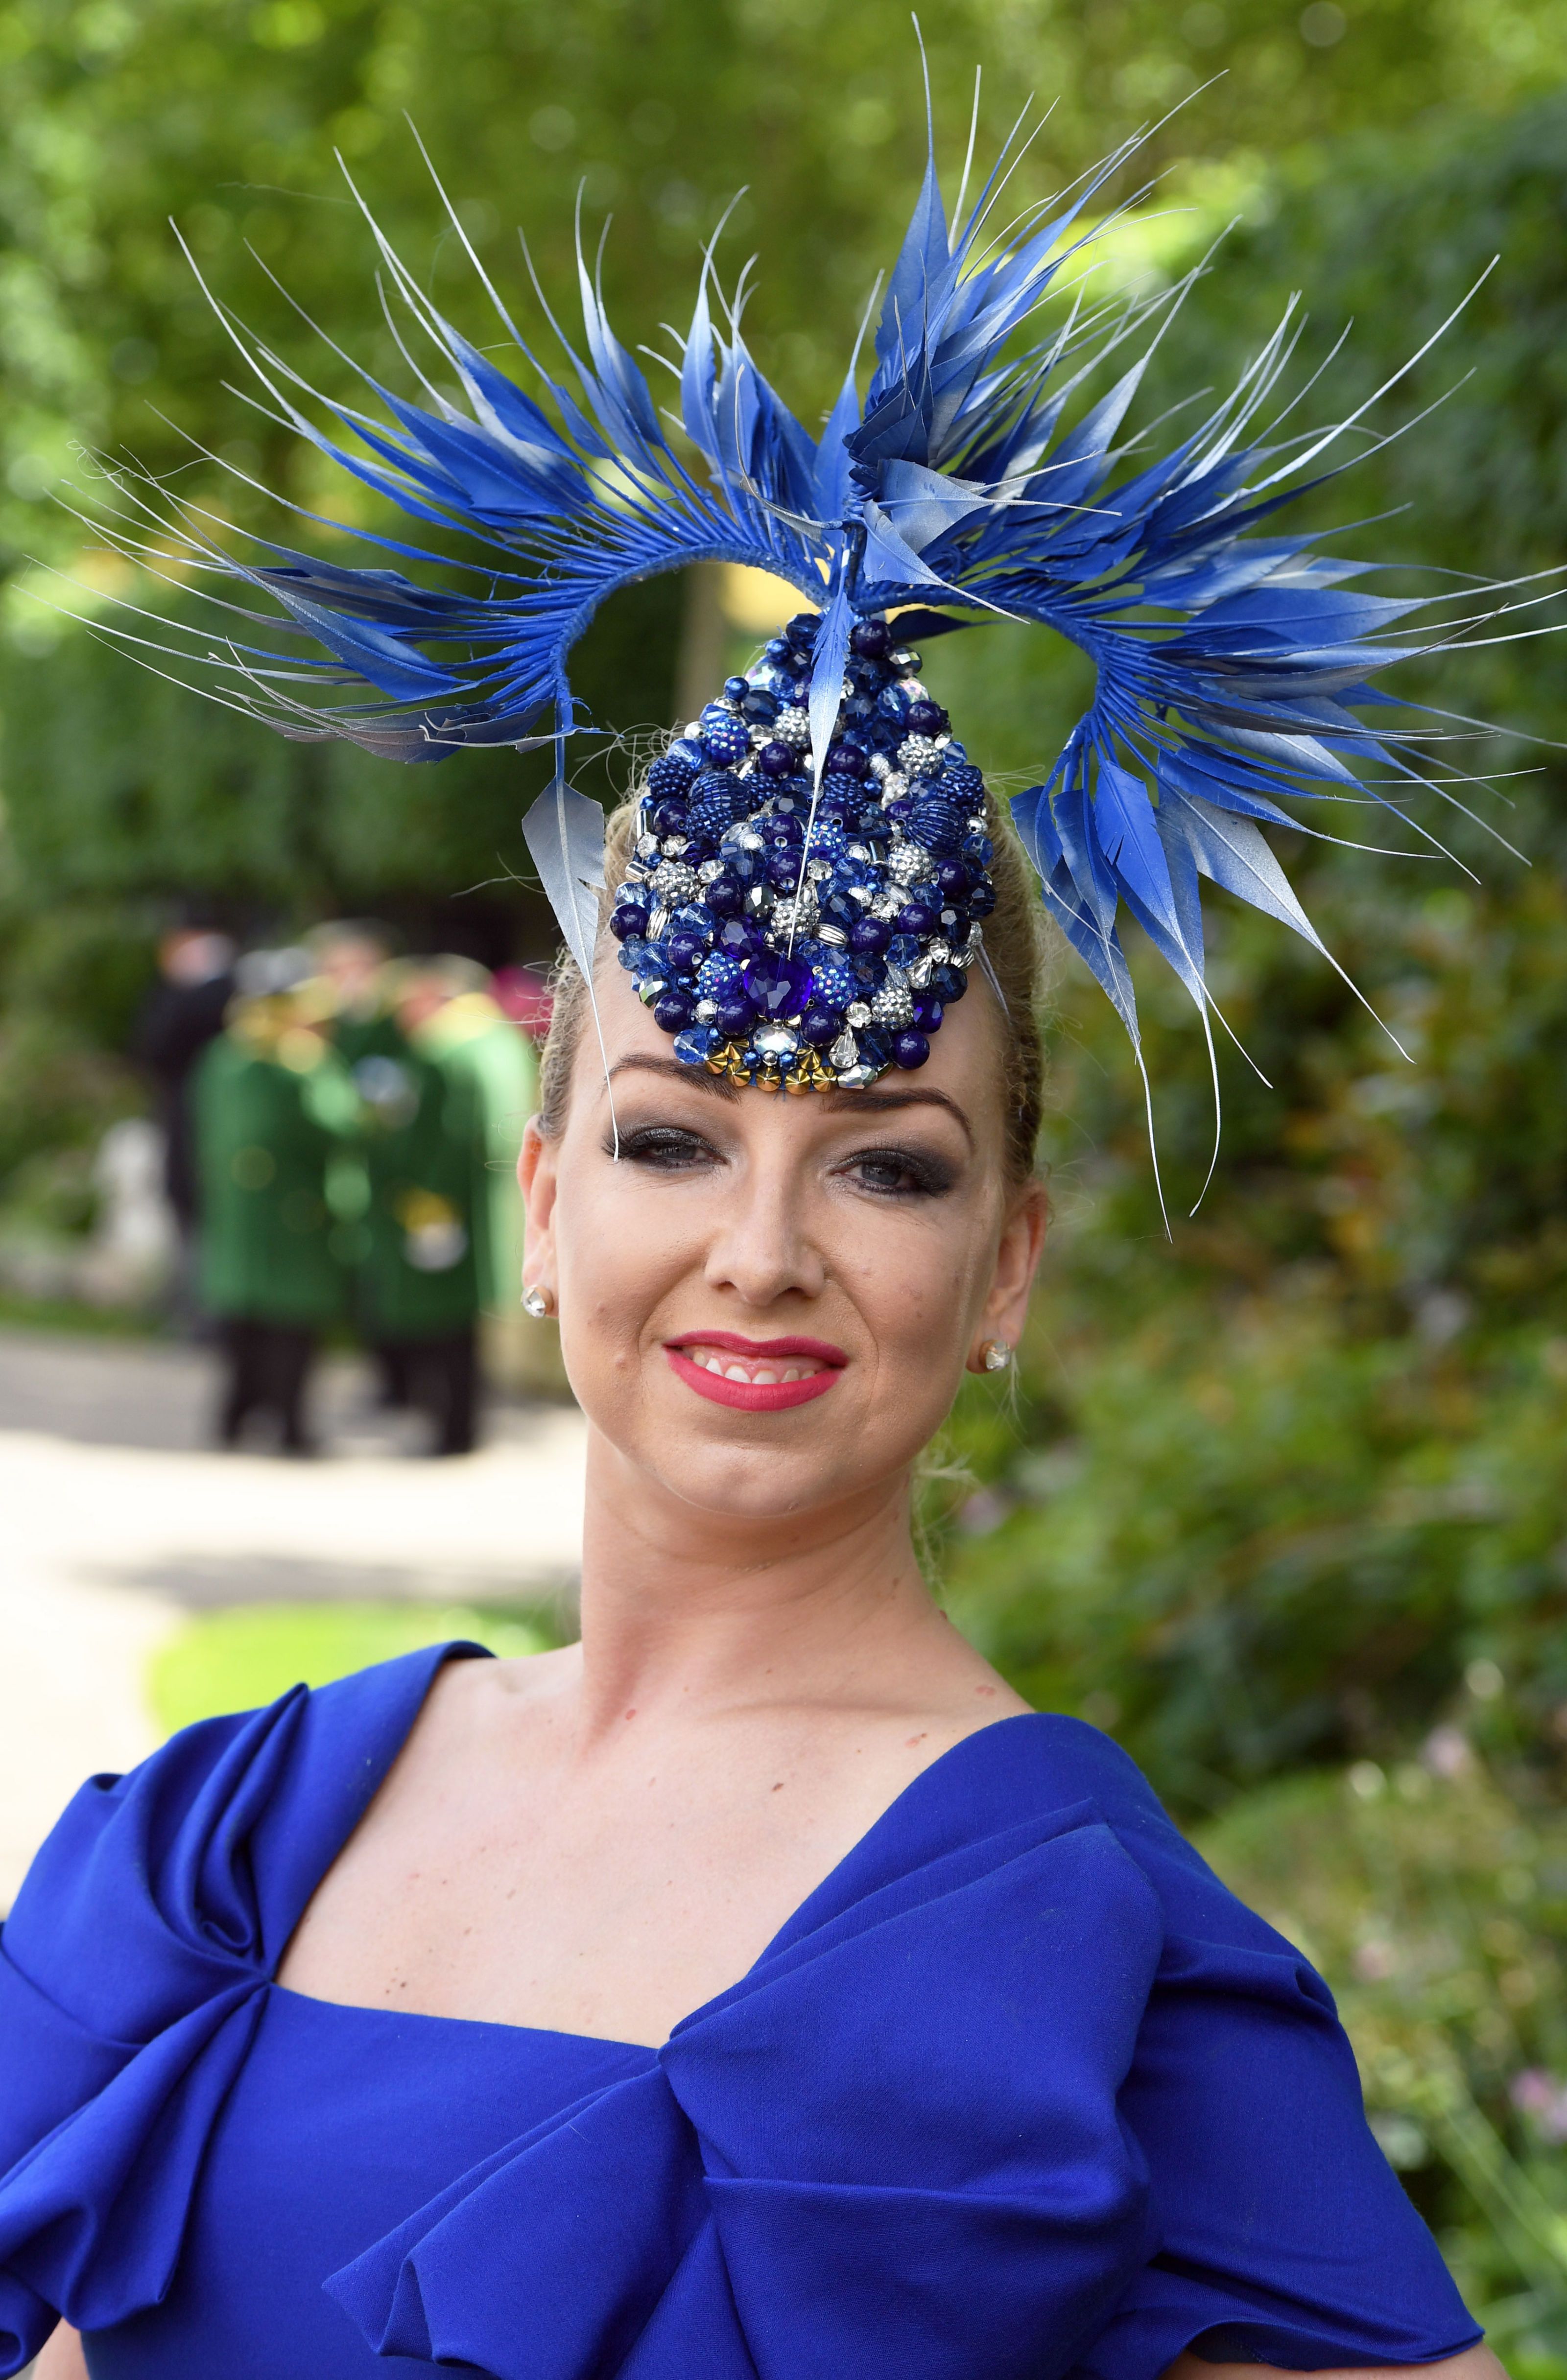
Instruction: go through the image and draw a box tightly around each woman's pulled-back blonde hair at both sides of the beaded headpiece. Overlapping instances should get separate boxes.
[538,793,1045,1183]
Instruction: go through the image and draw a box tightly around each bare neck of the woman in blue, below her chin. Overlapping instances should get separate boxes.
[576,1430,952,1749]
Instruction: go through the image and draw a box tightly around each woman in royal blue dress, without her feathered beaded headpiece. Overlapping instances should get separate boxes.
[0,766,1493,2380]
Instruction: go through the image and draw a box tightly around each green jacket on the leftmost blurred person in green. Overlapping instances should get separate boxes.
[195,1031,355,1330]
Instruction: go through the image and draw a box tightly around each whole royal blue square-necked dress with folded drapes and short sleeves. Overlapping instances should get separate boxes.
[0,1647,1479,2380]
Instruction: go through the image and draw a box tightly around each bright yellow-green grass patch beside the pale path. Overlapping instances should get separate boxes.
[148,1604,560,1735]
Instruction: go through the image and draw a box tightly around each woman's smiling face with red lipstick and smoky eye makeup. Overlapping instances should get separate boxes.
[522,966,1045,1518]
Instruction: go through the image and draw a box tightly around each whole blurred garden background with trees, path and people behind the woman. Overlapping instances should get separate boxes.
[0,0,1567,2351]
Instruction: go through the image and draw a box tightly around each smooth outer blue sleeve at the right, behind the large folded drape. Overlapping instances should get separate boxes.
[1024,1721,1481,2380]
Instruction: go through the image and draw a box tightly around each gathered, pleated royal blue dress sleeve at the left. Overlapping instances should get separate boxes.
[0,1647,467,2373]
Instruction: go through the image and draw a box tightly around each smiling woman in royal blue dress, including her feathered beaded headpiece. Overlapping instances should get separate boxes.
[0,107,1496,2380]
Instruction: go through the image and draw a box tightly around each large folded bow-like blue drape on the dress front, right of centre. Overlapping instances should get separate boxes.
[326,1806,1162,2380]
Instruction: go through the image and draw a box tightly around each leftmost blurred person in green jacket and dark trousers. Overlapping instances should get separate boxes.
[193,952,357,1454]
